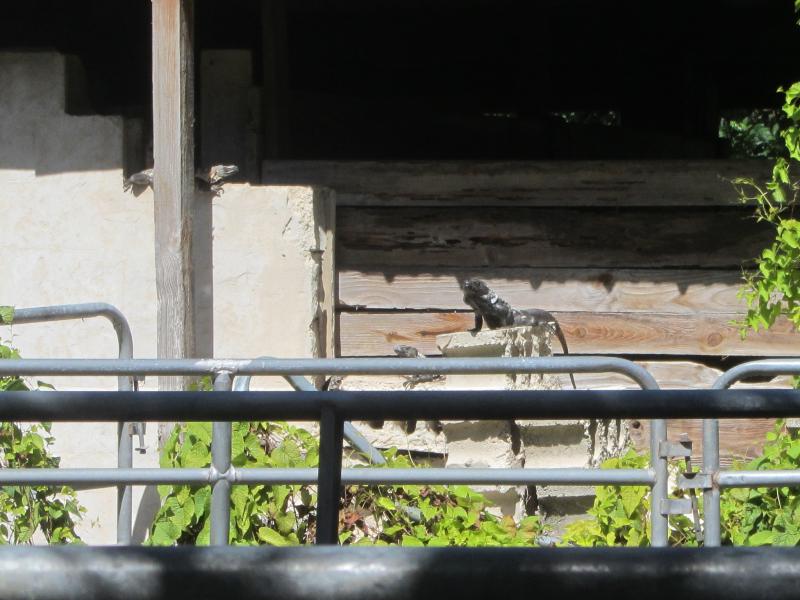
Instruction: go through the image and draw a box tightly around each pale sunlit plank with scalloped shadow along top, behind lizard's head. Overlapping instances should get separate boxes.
[339,269,743,313]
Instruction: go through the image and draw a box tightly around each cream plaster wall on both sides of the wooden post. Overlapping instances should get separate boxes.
[0,52,328,544]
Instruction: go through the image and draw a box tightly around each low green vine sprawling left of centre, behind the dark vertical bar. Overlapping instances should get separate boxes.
[148,422,543,546]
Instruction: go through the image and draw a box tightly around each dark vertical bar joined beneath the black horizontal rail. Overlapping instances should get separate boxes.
[317,407,344,544]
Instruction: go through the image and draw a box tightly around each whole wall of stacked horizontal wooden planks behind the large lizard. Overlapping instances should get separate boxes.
[326,161,800,462]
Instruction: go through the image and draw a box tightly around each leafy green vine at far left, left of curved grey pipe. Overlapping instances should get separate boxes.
[0,306,86,544]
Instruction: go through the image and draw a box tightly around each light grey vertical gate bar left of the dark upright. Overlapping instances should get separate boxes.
[210,371,233,546]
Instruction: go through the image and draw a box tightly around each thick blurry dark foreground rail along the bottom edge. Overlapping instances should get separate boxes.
[0,546,800,600]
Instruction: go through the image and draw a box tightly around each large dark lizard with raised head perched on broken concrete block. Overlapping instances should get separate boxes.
[461,277,578,389]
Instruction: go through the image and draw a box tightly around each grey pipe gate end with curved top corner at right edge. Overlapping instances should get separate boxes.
[703,359,800,547]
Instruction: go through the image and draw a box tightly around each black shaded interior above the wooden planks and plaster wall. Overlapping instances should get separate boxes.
[0,0,800,159]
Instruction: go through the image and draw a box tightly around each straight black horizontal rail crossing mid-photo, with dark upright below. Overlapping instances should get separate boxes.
[0,389,800,421]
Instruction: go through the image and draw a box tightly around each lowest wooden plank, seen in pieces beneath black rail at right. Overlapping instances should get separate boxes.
[630,419,775,470]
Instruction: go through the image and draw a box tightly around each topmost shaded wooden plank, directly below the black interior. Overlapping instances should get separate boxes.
[262,160,770,206]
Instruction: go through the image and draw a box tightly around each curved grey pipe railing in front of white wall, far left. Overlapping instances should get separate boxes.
[4,302,135,544]
